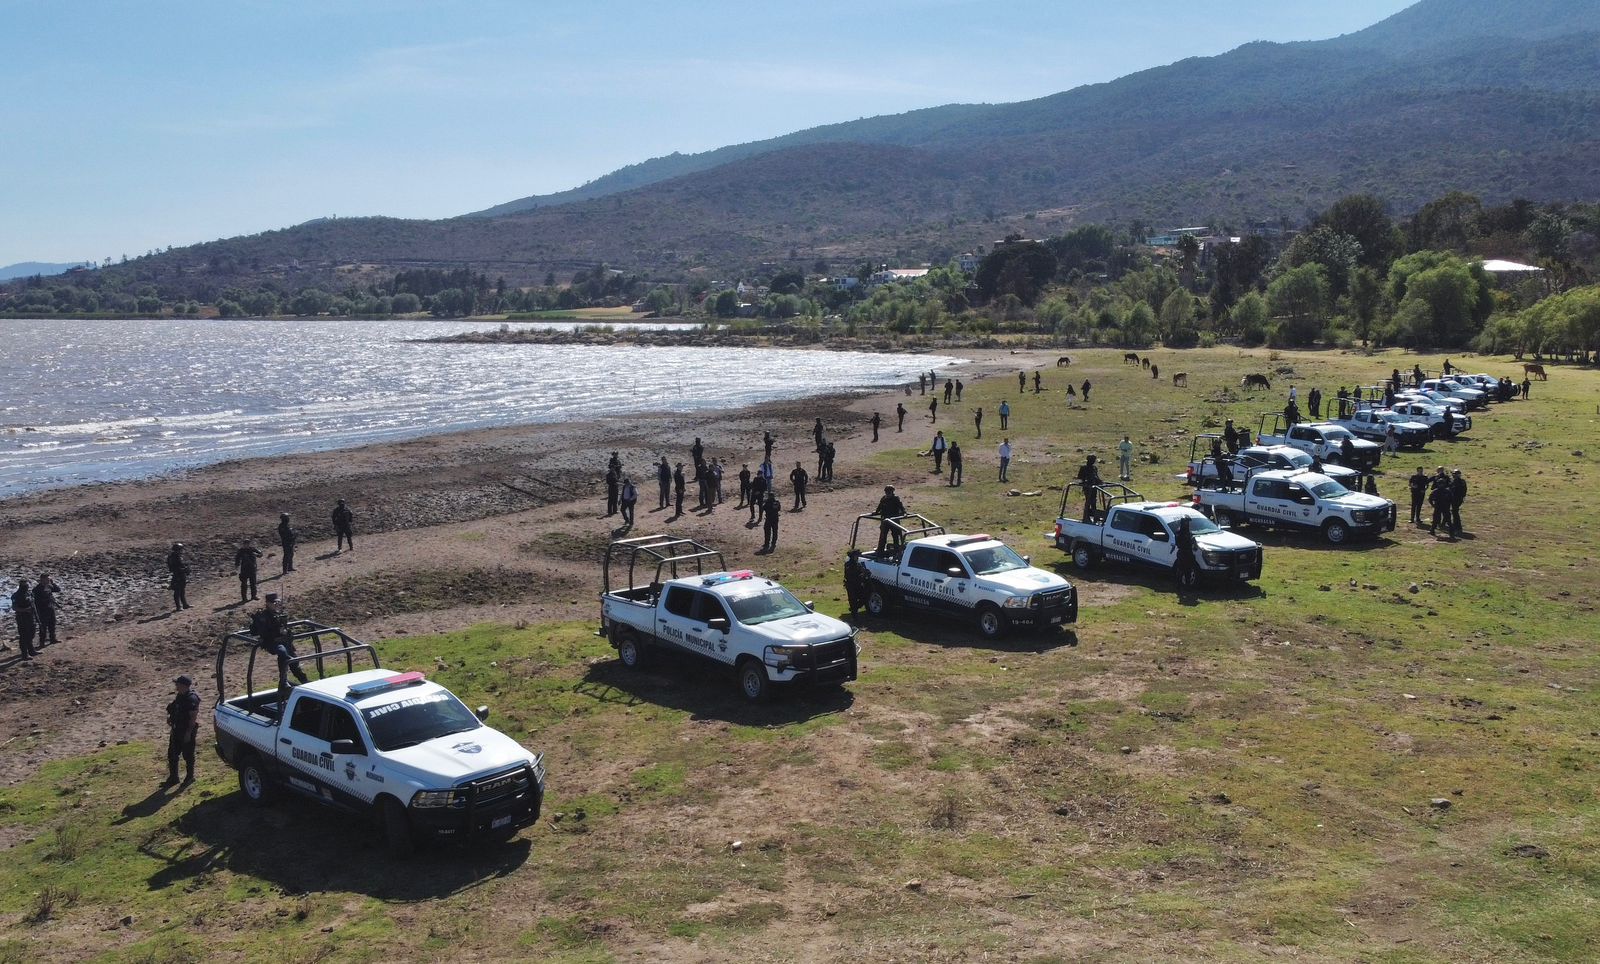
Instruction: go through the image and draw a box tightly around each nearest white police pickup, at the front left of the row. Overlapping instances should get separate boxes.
[213,620,544,857]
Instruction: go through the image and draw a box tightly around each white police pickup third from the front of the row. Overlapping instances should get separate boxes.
[850,514,1078,639]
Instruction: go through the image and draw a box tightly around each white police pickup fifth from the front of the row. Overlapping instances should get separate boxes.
[1194,469,1395,546]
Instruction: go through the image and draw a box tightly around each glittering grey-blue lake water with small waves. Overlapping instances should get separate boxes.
[0,319,955,498]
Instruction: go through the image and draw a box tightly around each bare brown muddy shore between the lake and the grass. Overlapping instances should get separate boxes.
[0,351,1017,783]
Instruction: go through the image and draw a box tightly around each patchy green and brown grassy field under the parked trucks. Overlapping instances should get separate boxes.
[0,349,1600,962]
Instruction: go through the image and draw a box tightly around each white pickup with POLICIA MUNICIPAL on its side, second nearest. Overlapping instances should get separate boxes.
[600,535,859,701]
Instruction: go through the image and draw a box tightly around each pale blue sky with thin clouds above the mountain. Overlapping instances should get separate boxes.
[0,0,1411,266]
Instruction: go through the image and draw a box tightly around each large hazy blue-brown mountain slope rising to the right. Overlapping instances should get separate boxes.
[43,0,1600,298]
